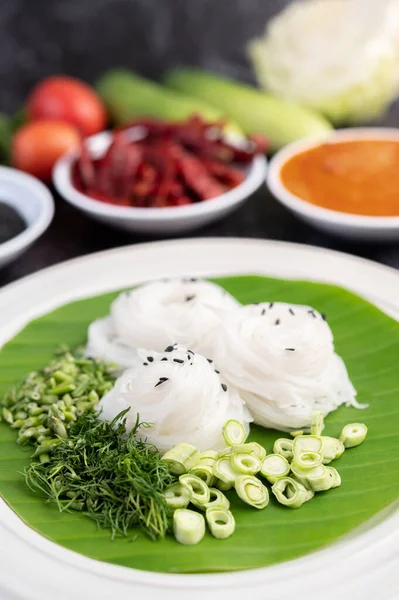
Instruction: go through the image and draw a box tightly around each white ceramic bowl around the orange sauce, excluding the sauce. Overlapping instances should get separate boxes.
[266,127,399,242]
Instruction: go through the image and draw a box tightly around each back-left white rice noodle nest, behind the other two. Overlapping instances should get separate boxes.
[87,278,239,370]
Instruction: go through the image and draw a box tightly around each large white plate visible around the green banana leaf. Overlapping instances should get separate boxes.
[0,239,399,600]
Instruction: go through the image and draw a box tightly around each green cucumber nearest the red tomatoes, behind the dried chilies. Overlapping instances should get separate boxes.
[95,69,239,131]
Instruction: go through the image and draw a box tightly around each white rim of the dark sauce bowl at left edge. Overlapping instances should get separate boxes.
[0,167,54,260]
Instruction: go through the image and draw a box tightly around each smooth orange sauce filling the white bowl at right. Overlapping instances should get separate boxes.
[280,139,399,217]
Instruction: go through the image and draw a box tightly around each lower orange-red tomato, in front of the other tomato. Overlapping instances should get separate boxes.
[11,121,81,181]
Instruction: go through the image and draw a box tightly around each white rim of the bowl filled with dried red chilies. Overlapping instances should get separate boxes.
[53,131,267,222]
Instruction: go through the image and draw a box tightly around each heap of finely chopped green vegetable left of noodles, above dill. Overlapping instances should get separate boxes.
[1,348,114,456]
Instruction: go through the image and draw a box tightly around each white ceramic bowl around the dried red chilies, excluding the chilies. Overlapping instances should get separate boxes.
[53,127,267,235]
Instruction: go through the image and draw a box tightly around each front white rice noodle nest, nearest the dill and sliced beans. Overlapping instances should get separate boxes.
[100,345,252,453]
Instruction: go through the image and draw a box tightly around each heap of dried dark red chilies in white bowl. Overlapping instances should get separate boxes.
[72,116,266,208]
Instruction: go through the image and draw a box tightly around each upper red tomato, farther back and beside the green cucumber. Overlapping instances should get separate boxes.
[26,76,107,136]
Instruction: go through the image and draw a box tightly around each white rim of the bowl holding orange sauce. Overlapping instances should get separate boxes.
[266,127,399,230]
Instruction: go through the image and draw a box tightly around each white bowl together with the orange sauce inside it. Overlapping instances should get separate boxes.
[267,127,399,241]
